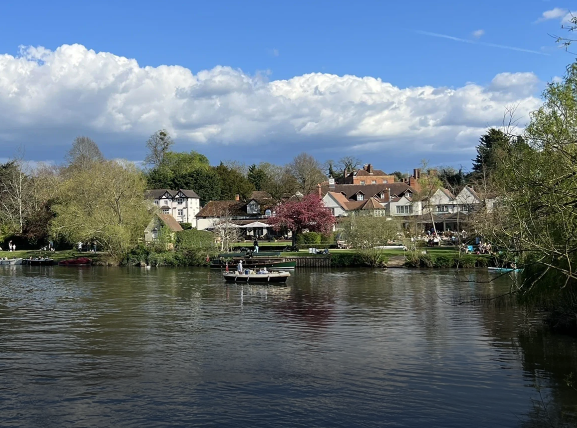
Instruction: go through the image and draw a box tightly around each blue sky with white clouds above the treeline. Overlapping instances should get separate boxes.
[0,0,577,172]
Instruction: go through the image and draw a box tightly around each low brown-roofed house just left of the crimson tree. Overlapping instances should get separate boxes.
[196,195,274,238]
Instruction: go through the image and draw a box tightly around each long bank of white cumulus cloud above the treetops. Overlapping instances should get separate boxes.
[0,45,540,164]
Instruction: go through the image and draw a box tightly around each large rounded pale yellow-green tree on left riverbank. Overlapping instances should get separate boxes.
[50,161,151,261]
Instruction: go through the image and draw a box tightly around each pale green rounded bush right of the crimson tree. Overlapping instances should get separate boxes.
[341,215,400,249]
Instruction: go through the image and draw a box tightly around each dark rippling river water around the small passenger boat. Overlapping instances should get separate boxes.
[0,266,577,427]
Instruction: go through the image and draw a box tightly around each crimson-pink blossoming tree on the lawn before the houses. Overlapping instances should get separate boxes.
[269,194,335,245]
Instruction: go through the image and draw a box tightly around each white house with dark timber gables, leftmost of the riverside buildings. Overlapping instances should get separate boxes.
[146,189,200,227]
